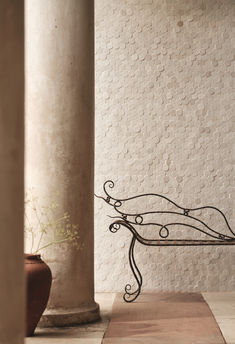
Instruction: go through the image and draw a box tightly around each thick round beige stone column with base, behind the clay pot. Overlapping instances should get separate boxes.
[25,0,99,326]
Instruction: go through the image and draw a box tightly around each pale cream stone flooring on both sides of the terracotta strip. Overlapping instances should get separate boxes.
[25,292,235,344]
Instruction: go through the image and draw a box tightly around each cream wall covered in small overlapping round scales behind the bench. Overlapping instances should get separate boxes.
[95,0,235,291]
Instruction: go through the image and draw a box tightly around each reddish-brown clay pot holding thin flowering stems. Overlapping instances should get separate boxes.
[24,254,52,337]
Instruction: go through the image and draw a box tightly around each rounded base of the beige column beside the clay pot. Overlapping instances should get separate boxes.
[38,302,100,327]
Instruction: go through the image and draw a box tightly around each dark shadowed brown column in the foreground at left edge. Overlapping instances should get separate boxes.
[0,0,25,344]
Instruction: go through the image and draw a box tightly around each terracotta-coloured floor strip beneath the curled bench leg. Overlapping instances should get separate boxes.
[103,293,225,344]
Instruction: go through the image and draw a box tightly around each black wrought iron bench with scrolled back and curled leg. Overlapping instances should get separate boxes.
[96,180,235,302]
